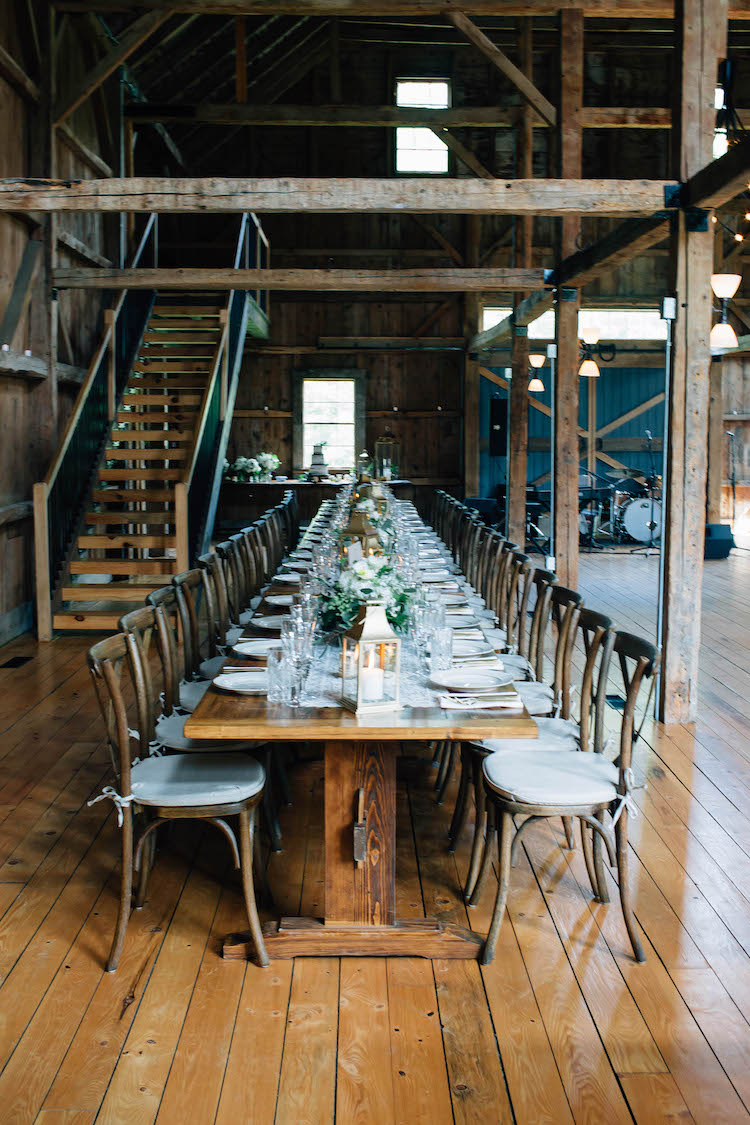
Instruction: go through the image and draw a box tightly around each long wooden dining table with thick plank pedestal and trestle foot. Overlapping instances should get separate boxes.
[184,660,537,959]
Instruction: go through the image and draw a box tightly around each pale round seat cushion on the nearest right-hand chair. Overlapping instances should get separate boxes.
[484,750,620,806]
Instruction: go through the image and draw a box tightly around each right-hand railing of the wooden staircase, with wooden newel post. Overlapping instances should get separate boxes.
[174,214,258,570]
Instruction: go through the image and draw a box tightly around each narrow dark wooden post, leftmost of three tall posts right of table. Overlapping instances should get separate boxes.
[506,19,534,550]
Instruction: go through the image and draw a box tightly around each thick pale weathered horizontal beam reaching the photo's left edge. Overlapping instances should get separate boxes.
[0,177,678,214]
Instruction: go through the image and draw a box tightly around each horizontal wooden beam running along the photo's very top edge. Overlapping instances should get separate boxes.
[55,0,750,20]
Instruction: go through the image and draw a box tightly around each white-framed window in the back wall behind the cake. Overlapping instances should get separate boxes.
[293,370,364,469]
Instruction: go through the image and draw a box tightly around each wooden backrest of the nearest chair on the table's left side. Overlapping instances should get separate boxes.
[87,633,143,797]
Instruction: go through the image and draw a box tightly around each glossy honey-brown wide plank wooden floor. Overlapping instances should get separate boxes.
[0,551,750,1125]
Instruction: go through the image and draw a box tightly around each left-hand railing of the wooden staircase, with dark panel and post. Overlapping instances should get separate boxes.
[34,215,157,640]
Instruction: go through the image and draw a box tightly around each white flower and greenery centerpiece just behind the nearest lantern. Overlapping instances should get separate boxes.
[320,556,414,632]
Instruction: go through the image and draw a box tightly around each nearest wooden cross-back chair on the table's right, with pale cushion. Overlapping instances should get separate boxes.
[482,632,660,964]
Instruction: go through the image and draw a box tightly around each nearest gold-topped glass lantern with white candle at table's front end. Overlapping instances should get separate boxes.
[341,602,401,714]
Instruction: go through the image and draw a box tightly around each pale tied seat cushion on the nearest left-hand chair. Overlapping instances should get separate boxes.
[130,754,265,808]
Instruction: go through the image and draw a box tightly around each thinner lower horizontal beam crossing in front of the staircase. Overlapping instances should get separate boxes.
[53,268,544,293]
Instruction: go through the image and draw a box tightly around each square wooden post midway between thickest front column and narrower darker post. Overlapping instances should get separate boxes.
[552,9,584,590]
